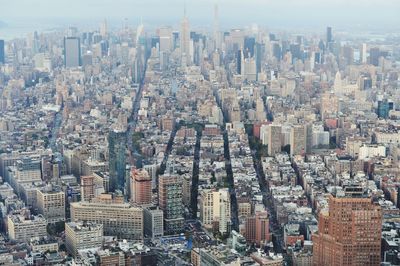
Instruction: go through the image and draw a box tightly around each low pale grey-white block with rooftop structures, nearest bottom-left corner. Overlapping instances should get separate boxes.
[6,209,47,242]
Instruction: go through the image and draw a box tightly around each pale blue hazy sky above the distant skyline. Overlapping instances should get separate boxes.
[0,0,400,28]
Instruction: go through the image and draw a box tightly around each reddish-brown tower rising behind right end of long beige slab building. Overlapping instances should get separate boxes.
[131,169,152,204]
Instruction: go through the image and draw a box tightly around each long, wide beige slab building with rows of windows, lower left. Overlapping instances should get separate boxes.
[71,200,143,239]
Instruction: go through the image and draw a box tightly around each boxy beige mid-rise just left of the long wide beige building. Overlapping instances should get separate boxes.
[36,188,65,223]
